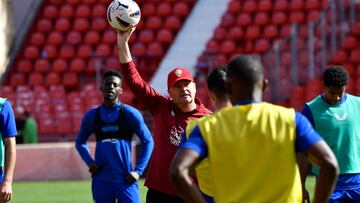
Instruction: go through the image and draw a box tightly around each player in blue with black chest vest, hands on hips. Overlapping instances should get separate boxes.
[76,70,154,203]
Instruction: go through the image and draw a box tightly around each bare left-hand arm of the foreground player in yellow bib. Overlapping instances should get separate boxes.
[170,148,206,203]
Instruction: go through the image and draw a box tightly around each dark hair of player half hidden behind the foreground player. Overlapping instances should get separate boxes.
[206,64,227,99]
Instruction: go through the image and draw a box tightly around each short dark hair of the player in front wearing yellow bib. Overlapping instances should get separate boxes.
[228,55,264,85]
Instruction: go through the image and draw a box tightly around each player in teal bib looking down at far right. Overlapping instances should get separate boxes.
[301,66,360,202]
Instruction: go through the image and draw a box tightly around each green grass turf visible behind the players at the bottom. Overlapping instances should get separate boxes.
[11,177,315,203]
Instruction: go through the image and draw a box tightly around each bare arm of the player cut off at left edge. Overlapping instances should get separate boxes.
[0,137,16,202]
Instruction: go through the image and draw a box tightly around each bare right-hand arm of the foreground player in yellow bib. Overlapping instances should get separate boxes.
[306,141,339,203]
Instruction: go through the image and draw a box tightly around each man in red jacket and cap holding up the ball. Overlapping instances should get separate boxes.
[117,28,211,203]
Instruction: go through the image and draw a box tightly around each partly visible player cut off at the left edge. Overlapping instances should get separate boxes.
[0,97,17,202]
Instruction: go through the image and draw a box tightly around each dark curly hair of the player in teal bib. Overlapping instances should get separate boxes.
[323,65,349,87]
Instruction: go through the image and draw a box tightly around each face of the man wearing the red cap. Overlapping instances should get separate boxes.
[168,80,196,105]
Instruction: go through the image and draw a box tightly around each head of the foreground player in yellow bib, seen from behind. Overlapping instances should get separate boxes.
[227,55,266,103]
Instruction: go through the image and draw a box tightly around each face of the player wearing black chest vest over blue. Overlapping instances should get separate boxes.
[101,76,122,101]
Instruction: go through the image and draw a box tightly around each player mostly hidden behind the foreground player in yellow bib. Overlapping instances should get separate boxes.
[182,65,232,203]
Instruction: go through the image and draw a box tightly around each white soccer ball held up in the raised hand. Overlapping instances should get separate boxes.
[107,0,141,31]
